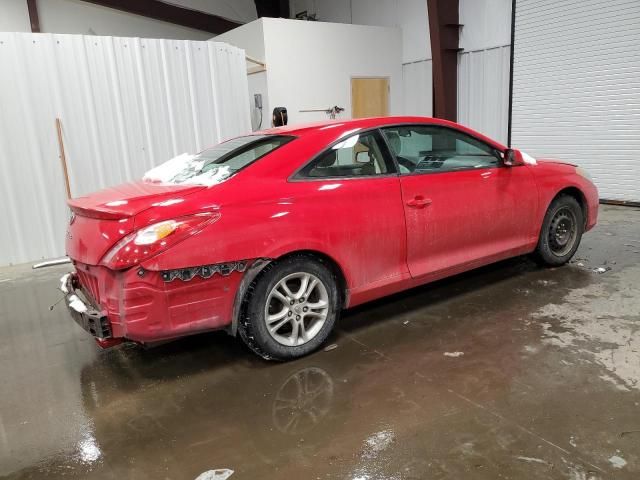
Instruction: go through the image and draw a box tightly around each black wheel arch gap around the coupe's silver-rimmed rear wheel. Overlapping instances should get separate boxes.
[229,249,349,336]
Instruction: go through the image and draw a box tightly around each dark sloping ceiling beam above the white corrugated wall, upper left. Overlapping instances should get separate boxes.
[82,0,242,35]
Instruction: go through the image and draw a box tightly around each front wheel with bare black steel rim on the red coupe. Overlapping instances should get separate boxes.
[535,195,584,267]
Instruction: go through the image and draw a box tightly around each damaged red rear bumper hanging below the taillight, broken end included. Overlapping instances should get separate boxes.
[61,262,243,343]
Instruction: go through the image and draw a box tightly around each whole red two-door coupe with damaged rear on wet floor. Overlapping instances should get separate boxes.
[61,117,598,360]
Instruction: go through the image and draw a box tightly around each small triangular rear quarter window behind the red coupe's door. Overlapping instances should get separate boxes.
[299,132,395,178]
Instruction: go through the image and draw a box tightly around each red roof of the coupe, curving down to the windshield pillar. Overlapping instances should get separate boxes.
[254,116,506,149]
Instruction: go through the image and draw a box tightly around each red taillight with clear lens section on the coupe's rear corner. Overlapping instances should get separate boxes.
[101,213,220,270]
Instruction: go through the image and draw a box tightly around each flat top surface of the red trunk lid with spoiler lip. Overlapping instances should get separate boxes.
[69,181,206,220]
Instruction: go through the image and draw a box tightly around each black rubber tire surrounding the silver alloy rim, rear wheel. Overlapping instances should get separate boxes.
[238,255,340,360]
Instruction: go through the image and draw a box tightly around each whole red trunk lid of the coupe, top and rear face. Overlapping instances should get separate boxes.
[66,182,206,265]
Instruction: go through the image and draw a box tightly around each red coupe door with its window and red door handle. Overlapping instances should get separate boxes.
[383,125,537,277]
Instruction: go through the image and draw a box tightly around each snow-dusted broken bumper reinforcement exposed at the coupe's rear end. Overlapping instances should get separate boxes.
[60,273,122,348]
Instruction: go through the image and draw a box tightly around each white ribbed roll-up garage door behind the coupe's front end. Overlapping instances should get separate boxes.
[512,0,640,201]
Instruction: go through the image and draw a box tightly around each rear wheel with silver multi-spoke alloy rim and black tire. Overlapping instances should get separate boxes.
[239,256,338,360]
